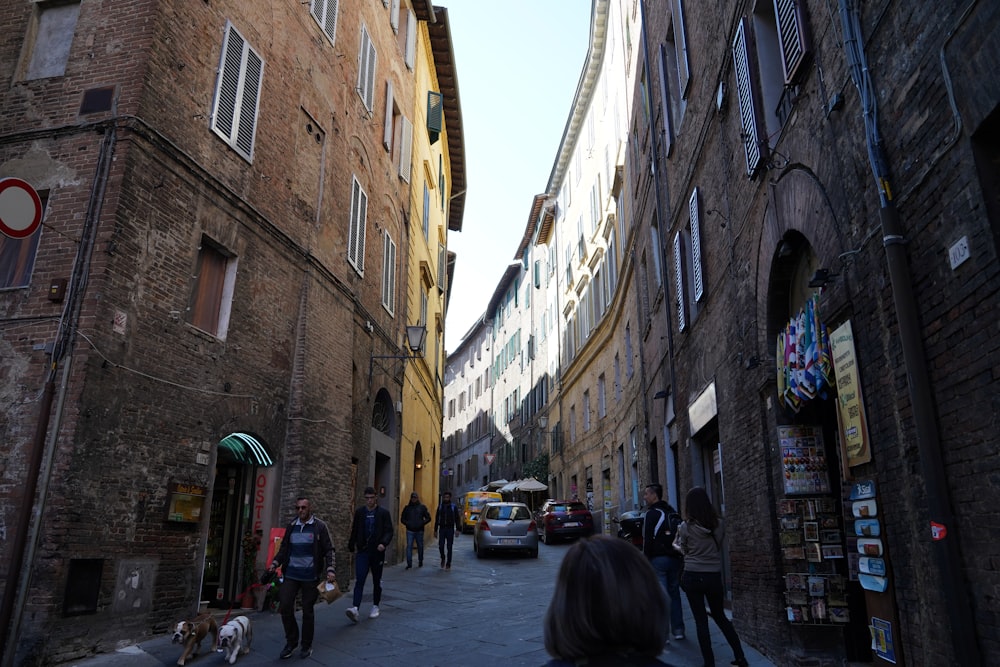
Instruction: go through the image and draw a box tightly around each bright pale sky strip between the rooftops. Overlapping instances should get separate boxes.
[435,0,591,352]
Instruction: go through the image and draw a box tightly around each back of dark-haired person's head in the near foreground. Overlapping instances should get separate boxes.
[544,535,670,667]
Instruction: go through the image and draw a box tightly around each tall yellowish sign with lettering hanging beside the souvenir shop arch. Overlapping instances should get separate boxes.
[830,320,872,468]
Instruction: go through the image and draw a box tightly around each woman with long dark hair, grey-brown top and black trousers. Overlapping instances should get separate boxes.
[674,486,748,667]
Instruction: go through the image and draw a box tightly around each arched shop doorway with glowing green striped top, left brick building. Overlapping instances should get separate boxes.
[201,433,275,607]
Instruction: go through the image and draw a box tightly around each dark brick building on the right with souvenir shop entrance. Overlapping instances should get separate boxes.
[626,0,1000,665]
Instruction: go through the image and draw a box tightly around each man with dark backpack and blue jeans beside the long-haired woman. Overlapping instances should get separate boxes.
[642,484,685,639]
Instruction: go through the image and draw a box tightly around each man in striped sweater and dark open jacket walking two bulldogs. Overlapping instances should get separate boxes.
[268,496,336,660]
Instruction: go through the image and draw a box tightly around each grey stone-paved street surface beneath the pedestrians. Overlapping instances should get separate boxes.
[67,536,773,667]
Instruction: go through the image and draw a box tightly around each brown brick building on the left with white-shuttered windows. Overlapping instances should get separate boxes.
[0,0,461,665]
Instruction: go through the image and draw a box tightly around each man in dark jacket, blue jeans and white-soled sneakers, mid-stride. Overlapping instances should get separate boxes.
[346,486,392,623]
